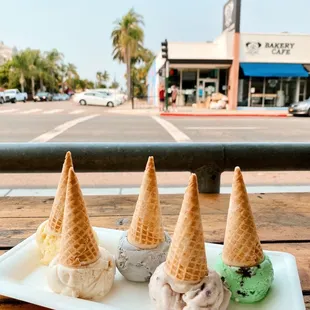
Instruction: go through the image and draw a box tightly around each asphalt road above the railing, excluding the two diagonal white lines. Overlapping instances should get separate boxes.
[0,102,310,142]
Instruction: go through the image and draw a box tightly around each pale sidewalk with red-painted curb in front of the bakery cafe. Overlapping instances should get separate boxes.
[109,102,290,117]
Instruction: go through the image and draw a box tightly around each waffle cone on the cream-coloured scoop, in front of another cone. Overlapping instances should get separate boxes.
[59,168,100,267]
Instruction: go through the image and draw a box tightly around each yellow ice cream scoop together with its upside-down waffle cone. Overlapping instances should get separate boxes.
[36,152,73,265]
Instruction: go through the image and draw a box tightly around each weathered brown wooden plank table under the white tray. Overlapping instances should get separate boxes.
[0,193,310,310]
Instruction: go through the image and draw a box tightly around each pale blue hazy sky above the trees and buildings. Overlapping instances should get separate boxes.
[0,0,310,85]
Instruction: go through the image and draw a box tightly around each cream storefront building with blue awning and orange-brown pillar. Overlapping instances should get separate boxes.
[148,0,310,110]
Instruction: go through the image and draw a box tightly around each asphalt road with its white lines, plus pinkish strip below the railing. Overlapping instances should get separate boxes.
[0,102,310,188]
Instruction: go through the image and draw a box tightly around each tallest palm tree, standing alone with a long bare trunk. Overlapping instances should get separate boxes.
[111,9,144,98]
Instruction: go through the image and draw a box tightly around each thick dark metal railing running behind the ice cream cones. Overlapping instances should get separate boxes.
[0,143,310,193]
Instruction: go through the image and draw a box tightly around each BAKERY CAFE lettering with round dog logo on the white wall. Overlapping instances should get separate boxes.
[246,42,295,55]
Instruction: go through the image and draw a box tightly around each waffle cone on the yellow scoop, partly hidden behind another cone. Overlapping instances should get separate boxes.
[48,152,73,233]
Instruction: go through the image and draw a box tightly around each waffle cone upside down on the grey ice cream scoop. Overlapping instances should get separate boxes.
[128,157,165,249]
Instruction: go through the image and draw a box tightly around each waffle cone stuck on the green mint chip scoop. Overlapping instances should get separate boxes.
[223,167,264,267]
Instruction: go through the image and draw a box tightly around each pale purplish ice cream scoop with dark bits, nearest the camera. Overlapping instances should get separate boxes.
[149,263,231,310]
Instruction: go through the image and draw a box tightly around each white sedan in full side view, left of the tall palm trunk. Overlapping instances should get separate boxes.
[73,91,119,107]
